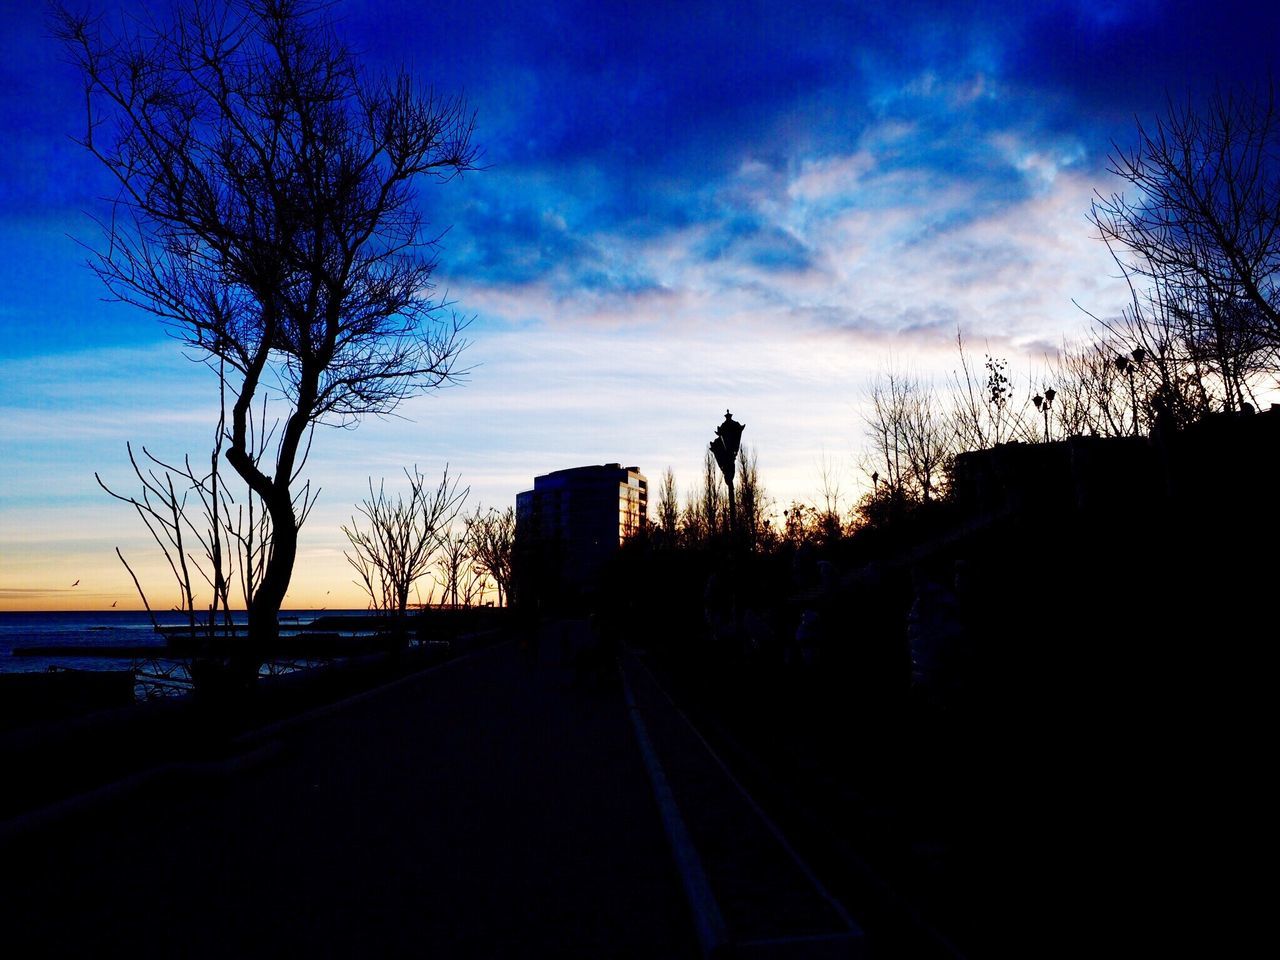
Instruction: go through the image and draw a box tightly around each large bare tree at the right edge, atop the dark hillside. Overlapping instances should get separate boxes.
[1091,83,1280,363]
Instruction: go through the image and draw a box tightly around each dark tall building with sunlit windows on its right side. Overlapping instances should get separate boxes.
[516,463,649,602]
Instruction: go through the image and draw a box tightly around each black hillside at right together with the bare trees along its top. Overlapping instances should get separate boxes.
[588,86,1280,955]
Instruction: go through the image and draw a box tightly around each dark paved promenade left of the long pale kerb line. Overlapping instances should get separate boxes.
[0,634,698,957]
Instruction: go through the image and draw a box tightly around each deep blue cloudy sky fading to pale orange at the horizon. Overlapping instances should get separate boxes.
[0,0,1280,609]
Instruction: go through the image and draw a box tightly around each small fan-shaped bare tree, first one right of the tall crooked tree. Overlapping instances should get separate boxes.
[342,466,471,617]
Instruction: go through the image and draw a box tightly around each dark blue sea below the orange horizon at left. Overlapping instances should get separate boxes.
[0,611,366,673]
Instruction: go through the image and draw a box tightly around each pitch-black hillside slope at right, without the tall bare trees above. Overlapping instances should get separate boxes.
[596,394,1280,955]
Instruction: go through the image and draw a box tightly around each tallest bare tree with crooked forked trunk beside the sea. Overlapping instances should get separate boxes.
[55,0,476,672]
